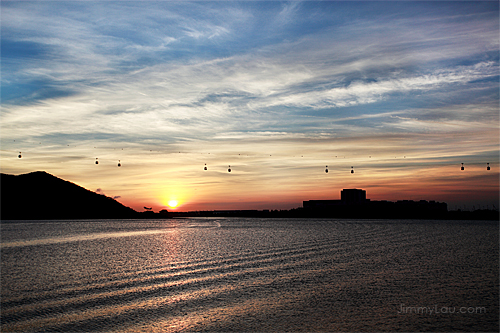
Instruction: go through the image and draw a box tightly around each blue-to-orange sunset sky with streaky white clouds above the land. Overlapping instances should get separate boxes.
[0,1,500,211]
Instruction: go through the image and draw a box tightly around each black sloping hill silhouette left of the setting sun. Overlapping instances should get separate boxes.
[0,171,140,220]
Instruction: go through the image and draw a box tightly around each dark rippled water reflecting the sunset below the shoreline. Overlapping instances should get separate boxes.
[0,218,499,332]
